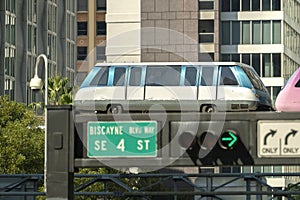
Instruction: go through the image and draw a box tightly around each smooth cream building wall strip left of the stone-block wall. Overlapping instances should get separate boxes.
[106,0,141,62]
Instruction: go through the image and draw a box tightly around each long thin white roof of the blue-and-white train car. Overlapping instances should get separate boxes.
[95,62,251,67]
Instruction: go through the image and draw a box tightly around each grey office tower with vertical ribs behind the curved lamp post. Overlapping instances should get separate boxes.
[0,0,76,104]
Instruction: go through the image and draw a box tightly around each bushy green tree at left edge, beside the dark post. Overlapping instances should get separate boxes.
[0,96,44,174]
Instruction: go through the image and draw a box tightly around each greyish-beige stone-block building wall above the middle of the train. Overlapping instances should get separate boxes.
[141,0,199,62]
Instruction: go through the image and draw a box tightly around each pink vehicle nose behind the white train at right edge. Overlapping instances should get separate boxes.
[275,68,300,112]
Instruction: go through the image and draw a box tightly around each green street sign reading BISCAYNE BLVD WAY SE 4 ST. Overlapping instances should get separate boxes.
[87,121,157,158]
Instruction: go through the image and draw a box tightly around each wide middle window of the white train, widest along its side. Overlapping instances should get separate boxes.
[146,66,181,86]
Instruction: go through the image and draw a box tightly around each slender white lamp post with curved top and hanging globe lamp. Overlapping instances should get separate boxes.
[29,54,48,191]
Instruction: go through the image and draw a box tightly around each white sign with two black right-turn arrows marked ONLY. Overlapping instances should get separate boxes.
[257,120,300,157]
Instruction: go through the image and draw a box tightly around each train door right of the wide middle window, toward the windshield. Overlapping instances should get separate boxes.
[198,66,218,101]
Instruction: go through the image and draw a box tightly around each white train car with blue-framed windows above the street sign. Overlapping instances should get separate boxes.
[74,62,272,113]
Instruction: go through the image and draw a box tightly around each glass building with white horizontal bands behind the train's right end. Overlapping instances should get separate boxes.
[199,0,300,103]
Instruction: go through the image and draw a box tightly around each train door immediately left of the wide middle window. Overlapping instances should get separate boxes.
[126,66,146,100]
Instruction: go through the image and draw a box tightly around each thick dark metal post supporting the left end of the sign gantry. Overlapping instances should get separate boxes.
[46,106,74,200]
